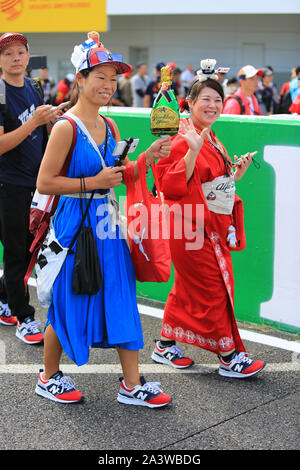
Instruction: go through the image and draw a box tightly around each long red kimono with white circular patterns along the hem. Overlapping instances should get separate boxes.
[156,132,245,353]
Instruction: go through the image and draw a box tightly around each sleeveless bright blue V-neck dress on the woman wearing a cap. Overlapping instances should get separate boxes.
[47,119,143,365]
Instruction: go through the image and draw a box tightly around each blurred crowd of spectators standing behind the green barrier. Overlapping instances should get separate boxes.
[108,62,300,116]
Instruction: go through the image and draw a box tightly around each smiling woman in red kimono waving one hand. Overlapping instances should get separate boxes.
[152,70,265,377]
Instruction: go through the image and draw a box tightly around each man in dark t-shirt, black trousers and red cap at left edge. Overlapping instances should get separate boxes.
[0,33,56,344]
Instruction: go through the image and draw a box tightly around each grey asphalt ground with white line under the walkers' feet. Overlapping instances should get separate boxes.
[0,288,300,458]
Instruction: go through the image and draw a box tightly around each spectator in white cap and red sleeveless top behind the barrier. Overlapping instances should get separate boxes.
[222,65,263,116]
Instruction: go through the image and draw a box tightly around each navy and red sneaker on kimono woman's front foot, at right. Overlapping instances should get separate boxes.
[218,351,266,379]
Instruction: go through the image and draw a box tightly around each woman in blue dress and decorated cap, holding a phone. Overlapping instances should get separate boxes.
[36,33,171,408]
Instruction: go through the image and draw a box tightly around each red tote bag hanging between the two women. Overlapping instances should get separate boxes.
[124,153,171,282]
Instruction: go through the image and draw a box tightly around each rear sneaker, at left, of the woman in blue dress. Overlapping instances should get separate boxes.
[35,369,84,403]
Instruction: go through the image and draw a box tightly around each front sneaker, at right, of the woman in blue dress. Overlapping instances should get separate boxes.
[118,377,172,408]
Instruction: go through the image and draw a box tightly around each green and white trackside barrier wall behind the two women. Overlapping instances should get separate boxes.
[0,107,300,333]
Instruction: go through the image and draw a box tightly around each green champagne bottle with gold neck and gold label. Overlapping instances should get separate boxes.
[151,66,180,137]
